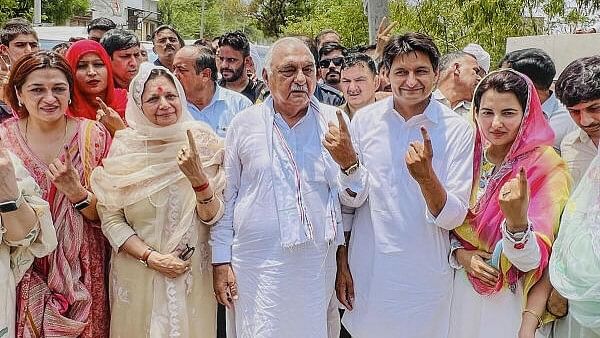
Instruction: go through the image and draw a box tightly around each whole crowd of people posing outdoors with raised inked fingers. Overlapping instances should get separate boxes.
[0,14,600,338]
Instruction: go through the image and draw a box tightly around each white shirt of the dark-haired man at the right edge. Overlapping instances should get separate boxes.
[560,128,598,187]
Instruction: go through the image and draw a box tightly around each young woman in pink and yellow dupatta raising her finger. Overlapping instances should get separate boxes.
[449,70,570,338]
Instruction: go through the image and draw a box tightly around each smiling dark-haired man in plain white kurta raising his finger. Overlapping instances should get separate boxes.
[338,34,473,338]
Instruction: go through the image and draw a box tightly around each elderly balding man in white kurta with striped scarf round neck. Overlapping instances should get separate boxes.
[212,38,355,338]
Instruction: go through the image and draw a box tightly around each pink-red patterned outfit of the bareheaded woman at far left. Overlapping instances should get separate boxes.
[0,119,110,337]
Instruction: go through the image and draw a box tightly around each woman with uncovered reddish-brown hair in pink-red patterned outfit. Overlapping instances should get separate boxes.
[0,52,110,338]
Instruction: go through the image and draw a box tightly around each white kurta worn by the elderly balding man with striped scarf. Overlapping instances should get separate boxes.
[211,99,342,338]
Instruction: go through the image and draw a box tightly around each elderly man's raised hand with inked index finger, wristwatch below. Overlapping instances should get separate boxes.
[323,110,358,169]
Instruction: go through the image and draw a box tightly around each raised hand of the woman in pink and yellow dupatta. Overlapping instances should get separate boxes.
[498,167,529,233]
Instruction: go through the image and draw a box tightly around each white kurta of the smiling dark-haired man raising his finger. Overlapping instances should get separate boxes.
[340,97,474,338]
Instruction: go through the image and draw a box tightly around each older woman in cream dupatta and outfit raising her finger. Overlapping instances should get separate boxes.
[92,64,224,338]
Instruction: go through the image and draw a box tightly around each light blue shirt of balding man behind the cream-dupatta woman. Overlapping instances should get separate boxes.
[188,85,252,137]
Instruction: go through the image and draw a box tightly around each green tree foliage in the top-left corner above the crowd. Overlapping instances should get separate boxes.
[0,0,89,25]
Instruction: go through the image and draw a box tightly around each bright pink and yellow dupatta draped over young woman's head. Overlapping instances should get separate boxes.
[454,69,571,299]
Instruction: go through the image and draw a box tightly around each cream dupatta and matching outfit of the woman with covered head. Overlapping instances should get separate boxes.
[91,63,225,338]
